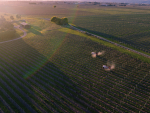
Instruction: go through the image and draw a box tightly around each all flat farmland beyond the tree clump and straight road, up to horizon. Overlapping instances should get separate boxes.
[0,2,150,53]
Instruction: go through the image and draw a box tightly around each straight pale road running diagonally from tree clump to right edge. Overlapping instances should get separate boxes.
[69,24,150,58]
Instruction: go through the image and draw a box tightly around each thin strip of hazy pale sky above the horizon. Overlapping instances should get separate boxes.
[0,0,150,3]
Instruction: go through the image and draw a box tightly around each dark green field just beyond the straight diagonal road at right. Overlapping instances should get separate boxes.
[73,14,150,53]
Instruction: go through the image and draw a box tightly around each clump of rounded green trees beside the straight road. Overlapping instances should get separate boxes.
[51,16,68,25]
